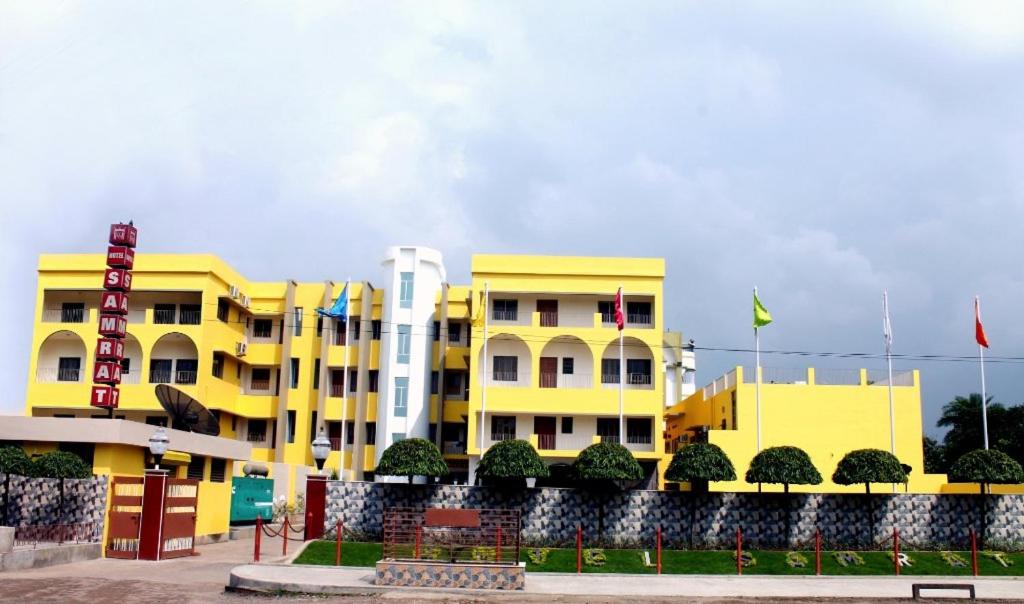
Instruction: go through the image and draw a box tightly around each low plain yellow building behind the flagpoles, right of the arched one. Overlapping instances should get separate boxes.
[666,366,1015,493]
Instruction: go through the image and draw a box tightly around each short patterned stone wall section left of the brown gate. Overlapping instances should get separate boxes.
[0,474,108,538]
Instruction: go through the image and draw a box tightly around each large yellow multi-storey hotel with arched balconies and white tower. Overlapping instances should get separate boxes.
[26,247,692,499]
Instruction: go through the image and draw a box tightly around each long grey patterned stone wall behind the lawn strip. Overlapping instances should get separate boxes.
[325,481,1024,550]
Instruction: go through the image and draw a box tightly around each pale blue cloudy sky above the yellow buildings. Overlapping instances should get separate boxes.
[0,0,1024,434]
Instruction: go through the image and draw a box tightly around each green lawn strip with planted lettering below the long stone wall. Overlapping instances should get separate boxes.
[295,541,1024,576]
